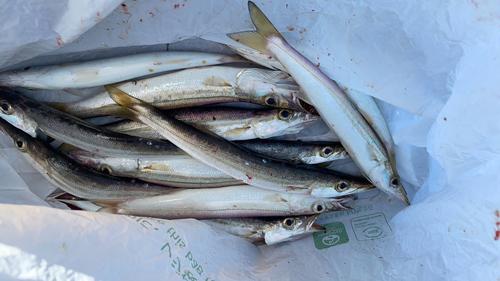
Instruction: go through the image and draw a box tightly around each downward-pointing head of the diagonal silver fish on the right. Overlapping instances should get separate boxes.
[369,162,410,206]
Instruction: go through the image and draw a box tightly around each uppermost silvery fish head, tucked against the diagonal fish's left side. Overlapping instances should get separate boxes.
[236,68,306,111]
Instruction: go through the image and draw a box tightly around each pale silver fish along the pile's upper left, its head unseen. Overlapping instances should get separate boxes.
[0,52,247,90]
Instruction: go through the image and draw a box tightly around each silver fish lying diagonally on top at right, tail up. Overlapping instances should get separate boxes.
[228,1,410,205]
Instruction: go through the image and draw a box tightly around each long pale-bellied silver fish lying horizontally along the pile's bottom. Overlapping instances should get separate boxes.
[96,185,356,219]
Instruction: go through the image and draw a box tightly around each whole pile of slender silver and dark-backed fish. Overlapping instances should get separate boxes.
[0,2,409,244]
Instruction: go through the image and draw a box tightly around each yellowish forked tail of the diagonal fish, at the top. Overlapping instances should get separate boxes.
[227,1,286,53]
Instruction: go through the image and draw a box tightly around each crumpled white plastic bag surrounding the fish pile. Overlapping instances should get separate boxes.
[0,0,500,280]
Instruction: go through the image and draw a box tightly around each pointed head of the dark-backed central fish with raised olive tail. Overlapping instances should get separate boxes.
[311,179,375,198]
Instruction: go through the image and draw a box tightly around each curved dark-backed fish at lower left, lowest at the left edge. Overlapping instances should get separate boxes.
[0,119,172,202]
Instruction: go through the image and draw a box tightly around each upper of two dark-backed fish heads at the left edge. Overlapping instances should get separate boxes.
[0,89,38,138]
